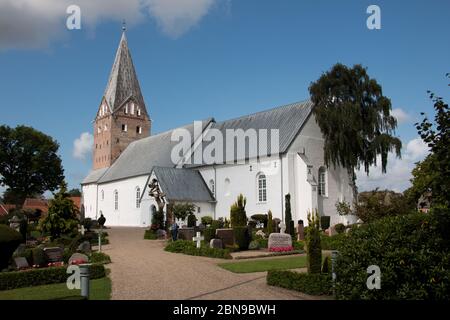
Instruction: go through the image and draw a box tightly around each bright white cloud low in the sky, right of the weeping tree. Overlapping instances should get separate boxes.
[356,138,429,192]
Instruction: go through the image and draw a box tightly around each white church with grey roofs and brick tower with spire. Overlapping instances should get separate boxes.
[82,32,353,227]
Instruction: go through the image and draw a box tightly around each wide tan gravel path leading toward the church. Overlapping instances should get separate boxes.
[103,227,315,300]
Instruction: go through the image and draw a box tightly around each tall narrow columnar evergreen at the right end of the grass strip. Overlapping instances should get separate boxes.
[306,210,322,273]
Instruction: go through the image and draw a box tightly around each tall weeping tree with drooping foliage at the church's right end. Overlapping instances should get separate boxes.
[309,63,402,179]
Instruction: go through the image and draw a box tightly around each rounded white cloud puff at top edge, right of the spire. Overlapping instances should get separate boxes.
[146,0,214,38]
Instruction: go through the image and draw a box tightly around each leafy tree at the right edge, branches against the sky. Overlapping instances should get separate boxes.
[409,78,450,207]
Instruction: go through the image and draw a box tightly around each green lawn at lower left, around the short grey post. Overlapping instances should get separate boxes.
[0,277,111,300]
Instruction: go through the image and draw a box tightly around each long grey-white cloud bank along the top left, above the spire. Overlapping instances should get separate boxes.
[0,0,218,50]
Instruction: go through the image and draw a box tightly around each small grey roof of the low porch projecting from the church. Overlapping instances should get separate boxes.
[153,167,214,202]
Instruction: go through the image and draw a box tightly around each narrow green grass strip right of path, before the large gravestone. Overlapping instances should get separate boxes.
[219,256,306,273]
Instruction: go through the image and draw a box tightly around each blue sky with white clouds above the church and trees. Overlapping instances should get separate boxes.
[0,0,450,195]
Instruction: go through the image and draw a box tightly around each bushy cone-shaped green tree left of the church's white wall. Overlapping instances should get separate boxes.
[39,183,79,240]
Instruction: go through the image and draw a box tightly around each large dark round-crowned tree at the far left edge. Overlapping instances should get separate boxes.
[0,125,64,206]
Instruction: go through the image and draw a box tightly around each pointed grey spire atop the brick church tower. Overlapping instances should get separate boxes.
[104,28,146,112]
